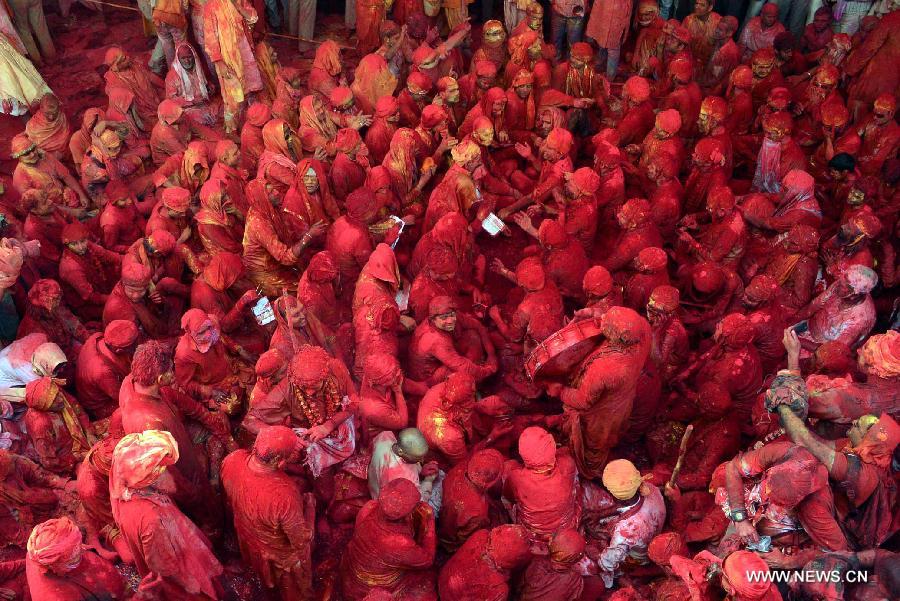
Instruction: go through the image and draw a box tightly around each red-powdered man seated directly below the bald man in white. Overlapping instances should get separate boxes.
[339,478,438,601]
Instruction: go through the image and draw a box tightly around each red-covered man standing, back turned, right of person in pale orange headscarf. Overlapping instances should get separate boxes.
[222,426,315,601]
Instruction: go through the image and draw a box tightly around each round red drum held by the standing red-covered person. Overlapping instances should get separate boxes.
[525,319,601,380]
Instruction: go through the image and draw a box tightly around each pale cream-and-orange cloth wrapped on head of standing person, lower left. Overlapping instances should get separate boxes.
[110,430,178,501]
